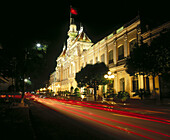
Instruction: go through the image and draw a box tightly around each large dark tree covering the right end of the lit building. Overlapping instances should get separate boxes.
[125,32,170,100]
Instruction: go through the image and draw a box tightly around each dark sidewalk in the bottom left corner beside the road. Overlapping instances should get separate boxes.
[0,100,34,140]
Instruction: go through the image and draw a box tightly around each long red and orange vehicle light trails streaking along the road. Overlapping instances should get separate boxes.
[0,95,170,140]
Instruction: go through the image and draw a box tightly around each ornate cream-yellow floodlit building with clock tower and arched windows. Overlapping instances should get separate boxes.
[50,17,170,97]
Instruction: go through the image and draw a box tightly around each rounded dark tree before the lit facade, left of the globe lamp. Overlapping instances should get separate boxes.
[75,62,109,100]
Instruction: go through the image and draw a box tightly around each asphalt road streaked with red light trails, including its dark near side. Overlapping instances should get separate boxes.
[30,98,170,140]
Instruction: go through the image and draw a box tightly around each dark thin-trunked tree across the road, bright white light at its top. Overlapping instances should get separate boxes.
[17,44,47,97]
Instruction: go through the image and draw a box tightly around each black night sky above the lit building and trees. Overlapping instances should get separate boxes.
[0,0,169,88]
